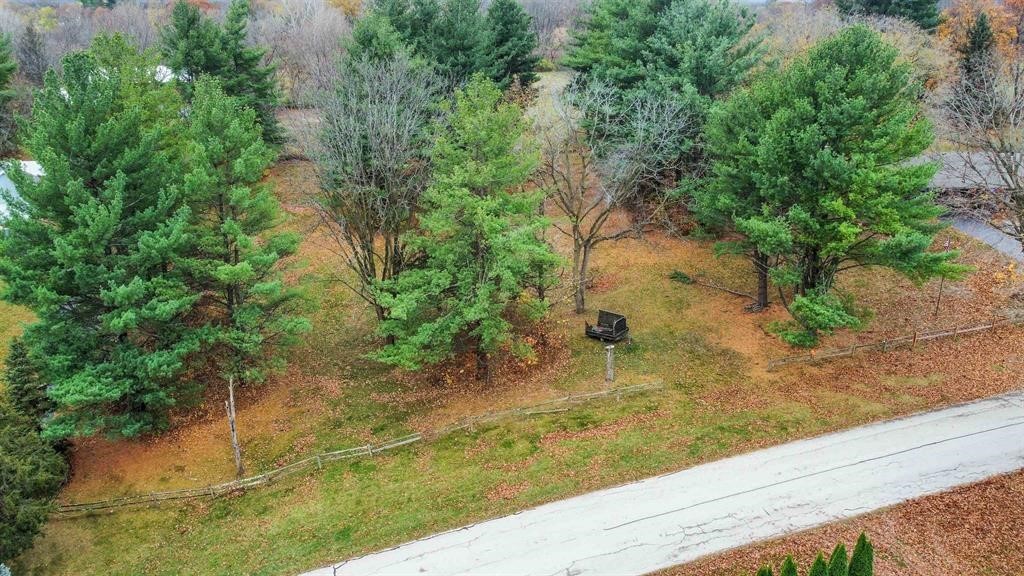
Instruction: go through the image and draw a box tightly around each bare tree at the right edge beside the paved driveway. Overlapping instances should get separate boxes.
[942,53,1024,245]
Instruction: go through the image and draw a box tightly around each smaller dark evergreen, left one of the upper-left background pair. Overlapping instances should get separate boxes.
[160,0,227,100]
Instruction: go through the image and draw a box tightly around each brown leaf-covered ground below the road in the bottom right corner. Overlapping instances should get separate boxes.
[658,472,1024,576]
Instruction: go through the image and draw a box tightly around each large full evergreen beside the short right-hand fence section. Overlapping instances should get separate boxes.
[696,26,965,344]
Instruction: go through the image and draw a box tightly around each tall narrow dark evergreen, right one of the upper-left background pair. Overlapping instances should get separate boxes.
[219,0,284,145]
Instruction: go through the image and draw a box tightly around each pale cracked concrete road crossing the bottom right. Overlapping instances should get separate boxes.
[308,393,1024,576]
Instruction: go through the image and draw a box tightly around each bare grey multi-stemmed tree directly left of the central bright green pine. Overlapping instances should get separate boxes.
[310,56,441,320]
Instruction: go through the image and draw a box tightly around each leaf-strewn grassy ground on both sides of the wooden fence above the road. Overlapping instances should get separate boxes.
[17,73,1024,575]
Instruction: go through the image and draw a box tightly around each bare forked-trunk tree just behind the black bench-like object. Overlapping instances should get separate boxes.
[538,84,690,314]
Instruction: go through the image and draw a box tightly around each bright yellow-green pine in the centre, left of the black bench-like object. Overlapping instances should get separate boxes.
[376,77,555,378]
